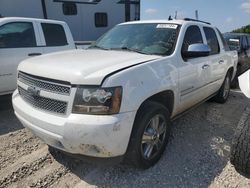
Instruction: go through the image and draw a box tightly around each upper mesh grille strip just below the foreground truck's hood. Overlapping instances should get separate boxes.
[18,72,70,95]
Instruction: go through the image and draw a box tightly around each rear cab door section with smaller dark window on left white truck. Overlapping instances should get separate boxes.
[39,22,72,53]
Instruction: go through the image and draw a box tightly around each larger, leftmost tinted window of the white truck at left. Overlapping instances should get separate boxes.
[0,22,37,48]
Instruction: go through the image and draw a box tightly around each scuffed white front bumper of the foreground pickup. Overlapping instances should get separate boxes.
[12,92,136,158]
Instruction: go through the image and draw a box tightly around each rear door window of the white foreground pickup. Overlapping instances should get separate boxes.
[204,27,220,55]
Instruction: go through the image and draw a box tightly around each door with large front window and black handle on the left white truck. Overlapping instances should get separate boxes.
[0,21,43,95]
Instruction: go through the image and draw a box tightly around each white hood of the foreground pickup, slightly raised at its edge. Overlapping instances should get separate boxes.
[18,49,161,85]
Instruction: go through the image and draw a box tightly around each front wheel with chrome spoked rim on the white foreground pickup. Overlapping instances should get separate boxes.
[125,101,170,169]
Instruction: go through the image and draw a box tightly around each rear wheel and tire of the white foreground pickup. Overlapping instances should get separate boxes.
[213,72,231,104]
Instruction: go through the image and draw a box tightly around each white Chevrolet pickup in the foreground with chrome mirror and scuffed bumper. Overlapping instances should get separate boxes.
[12,19,237,168]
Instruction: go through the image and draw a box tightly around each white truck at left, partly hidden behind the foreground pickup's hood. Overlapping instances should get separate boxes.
[0,17,76,95]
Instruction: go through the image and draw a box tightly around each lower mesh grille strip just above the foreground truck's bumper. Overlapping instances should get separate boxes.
[18,87,68,114]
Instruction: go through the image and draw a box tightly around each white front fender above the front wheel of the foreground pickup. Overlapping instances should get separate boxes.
[103,58,178,113]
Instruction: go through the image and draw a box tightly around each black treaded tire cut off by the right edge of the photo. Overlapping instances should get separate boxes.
[230,109,250,175]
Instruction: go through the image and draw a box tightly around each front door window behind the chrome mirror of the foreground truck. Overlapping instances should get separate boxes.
[181,25,203,52]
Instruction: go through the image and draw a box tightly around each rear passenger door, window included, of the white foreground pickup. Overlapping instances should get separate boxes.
[203,27,226,94]
